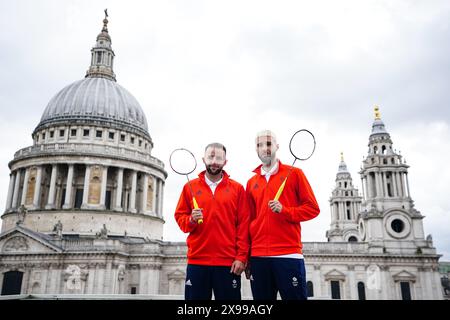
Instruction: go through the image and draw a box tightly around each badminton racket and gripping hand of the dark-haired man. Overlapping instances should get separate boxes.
[169,148,203,224]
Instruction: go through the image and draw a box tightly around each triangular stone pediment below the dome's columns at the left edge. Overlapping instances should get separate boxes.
[0,226,63,254]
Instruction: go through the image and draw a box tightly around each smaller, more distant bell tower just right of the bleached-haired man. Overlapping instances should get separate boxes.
[326,152,362,242]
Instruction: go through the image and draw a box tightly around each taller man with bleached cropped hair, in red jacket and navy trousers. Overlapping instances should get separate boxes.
[246,130,320,300]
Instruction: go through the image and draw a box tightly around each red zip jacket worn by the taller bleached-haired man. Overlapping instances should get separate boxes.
[246,162,320,257]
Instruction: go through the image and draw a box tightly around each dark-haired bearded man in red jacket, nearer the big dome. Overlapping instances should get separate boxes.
[175,143,249,300]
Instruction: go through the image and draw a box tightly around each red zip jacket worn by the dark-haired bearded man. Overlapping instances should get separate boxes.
[175,171,250,266]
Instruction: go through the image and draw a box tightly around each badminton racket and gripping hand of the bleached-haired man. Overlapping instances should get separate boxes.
[269,129,316,213]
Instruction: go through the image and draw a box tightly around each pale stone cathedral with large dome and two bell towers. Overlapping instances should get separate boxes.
[0,18,443,300]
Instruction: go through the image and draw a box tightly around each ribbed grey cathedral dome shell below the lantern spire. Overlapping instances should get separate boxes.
[35,77,149,136]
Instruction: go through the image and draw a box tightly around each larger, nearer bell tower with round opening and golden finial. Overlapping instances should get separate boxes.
[358,107,431,254]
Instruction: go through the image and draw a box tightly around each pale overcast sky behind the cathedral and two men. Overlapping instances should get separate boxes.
[0,0,450,260]
